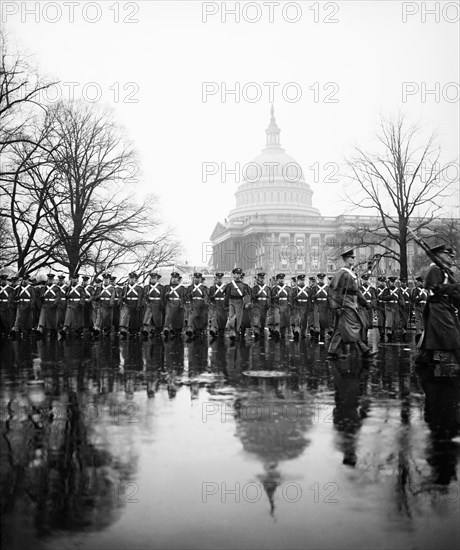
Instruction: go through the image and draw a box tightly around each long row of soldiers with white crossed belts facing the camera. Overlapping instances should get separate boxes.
[0,268,426,342]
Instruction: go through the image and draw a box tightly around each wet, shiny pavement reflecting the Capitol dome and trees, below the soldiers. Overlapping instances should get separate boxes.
[0,334,460,550]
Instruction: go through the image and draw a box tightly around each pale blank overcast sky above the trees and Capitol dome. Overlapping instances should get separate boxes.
[2,0,460,264]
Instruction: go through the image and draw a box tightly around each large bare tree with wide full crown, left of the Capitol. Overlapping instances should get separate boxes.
[40,102,174,272]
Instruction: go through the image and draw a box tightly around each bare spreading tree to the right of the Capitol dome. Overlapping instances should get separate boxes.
[346,116,452,277]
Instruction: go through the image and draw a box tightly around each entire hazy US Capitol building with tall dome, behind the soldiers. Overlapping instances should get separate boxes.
[210,105,450,276]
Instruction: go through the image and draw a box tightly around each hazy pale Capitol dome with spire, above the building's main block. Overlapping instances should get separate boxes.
[229,106,320,220]
